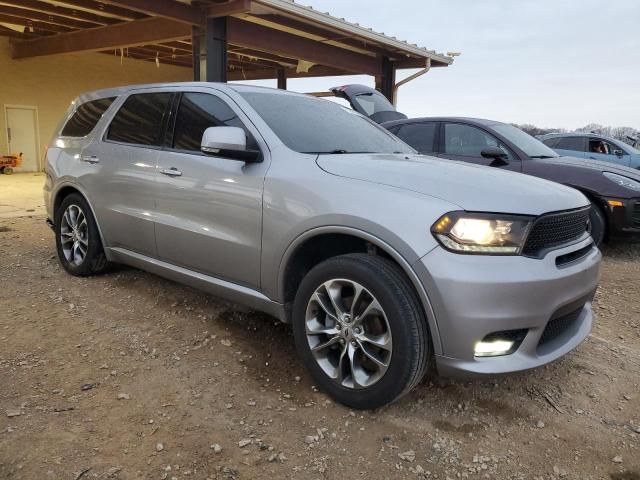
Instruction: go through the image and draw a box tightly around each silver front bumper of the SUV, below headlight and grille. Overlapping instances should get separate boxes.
[415,237,602,376]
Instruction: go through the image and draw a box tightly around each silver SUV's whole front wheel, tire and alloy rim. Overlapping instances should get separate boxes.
[293,254,431,409]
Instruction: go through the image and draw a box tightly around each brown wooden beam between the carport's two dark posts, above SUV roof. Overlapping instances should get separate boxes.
[227,17,382,75]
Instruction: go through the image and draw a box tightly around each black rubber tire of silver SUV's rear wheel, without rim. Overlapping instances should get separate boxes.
[54,193,110,277]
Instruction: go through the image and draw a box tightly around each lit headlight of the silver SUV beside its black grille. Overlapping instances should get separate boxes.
[431,212,533,255]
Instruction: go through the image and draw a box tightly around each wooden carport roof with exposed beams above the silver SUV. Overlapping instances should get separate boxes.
[0,0,453,80]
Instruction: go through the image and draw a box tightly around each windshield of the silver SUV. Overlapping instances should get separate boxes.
[238,89,415,154]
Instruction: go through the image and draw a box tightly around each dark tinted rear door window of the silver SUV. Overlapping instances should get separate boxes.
[107,92,172,146]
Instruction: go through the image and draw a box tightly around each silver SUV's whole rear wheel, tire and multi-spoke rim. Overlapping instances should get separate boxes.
[55,193,109,277]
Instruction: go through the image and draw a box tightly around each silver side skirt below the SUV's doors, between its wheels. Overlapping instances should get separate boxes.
[105,248,287,322]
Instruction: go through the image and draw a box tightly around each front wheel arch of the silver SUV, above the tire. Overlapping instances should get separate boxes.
[278,226,442,354]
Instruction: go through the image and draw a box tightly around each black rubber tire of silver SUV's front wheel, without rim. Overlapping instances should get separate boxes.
[293,254,431,409]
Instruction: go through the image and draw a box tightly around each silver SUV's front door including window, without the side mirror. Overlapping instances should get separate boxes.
[155,89,268,287]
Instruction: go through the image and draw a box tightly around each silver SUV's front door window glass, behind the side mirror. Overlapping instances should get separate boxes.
[173,93,258,152]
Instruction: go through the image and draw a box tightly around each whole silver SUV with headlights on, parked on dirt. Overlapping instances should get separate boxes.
[45,83,601,408]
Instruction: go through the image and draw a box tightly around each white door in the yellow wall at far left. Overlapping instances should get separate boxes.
[5,107,40,172]
